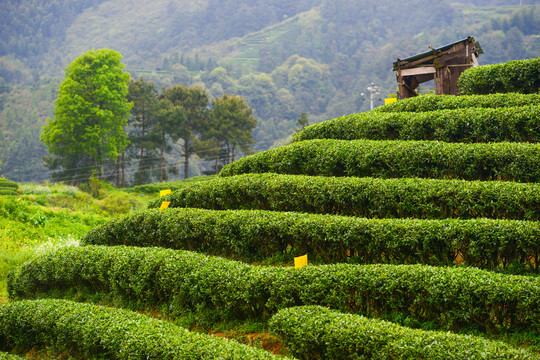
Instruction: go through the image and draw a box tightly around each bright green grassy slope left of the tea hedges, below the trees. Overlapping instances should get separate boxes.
[0,176,216,302]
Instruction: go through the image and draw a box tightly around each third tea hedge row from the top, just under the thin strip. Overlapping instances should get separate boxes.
[293,106,540,142]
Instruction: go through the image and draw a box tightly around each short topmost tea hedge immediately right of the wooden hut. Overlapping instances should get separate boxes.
[458,57,540,95]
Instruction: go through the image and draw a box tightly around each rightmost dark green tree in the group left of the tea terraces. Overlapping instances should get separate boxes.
[204,94,257,174]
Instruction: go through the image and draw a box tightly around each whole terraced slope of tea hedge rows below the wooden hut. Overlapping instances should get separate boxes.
[0,59,540,359]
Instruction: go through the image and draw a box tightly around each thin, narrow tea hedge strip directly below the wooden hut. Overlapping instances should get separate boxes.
[373,93,540,112]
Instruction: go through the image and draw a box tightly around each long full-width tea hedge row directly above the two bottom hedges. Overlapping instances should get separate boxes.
[8,246,540,331]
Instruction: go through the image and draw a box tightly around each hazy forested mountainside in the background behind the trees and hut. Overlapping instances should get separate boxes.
[0,0,540,181]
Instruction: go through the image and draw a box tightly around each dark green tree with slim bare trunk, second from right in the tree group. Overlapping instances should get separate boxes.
[160,85,209,179]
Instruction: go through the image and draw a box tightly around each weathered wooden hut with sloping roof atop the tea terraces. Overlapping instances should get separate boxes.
[394,36,484,99]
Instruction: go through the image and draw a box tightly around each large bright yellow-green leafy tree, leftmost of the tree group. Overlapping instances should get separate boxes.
[40,49,133,181]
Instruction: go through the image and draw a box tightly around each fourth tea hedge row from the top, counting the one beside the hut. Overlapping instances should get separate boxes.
[220,139,540,182]
